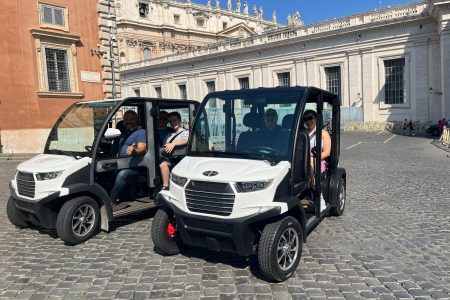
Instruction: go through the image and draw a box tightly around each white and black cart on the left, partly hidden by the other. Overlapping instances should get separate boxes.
[7,98,199,244]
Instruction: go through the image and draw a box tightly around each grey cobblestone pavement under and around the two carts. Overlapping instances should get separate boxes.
[0,133,450,299]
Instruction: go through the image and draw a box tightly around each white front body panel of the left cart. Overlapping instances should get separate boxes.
[11,154,92,201]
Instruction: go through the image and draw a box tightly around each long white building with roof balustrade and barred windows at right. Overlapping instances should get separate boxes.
[121,0,450,122]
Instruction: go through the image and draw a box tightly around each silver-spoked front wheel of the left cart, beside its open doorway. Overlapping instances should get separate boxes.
[56,197,100,245]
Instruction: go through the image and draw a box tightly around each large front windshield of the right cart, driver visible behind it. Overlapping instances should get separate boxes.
[188,88,304,164]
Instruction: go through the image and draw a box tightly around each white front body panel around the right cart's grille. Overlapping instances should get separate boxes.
[162,157,291,219]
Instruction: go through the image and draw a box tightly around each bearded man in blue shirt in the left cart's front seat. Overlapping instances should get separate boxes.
[110,110,147,211]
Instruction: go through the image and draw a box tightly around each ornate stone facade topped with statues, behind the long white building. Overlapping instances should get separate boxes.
[115,0,282,64]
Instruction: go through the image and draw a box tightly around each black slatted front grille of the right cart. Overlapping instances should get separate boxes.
[186,181,235,216]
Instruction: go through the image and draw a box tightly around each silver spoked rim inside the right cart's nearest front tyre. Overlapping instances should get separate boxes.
[277,228,299,271]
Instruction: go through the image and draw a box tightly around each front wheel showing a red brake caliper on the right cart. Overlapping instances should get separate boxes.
[152,209,180,255]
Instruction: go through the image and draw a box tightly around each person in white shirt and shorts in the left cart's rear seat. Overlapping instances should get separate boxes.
[159,112,189,190]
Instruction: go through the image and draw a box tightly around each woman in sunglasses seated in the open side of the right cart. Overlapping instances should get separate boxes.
[303,110,331,183]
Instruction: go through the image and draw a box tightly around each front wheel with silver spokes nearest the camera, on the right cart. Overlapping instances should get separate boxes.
[258,217,303,282]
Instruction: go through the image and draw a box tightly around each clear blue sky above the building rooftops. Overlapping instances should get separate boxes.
[192,0,414,24]
